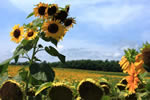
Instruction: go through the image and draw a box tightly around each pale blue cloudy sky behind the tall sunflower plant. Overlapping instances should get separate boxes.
[0,0,150,62]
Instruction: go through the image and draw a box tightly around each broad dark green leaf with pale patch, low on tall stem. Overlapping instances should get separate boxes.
[29,63,55,82]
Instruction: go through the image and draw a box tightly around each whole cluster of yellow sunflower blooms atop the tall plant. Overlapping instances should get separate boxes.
[10,2,76,43]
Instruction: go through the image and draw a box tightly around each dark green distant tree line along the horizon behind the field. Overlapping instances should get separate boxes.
[11,60,150,72]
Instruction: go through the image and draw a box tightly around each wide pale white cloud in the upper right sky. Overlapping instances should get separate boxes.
[79,5,143,28]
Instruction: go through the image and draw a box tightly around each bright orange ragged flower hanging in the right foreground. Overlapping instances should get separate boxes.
[126,63,140,93]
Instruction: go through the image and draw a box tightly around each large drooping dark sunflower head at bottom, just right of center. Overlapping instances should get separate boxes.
[77,78,104,100]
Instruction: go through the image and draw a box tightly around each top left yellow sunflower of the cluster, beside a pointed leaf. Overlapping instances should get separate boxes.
[34,2,48,18]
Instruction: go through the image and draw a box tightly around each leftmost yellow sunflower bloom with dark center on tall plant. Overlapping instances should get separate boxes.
[10,24,24,43]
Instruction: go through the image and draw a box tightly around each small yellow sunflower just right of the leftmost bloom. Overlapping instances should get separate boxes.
[25,29,38,40]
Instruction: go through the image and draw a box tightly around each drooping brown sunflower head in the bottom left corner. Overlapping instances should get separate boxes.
[0,80,23,100]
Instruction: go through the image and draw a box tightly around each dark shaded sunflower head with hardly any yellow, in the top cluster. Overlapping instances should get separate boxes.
[54,10,68,22]
